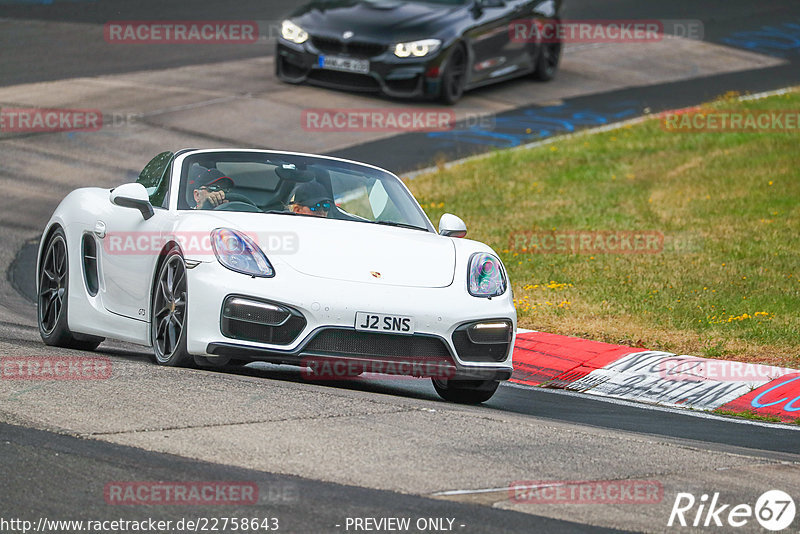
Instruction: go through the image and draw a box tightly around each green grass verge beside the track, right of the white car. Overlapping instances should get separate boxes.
[408,92,800,367]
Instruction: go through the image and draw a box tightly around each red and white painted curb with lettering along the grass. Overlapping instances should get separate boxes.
[511,329,800,422]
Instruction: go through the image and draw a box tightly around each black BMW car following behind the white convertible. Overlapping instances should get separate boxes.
[275,0,562,104]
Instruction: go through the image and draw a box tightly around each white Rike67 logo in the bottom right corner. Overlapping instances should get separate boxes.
[667,490,796,532]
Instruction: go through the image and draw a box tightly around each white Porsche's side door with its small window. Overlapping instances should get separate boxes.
[95,152,174,321]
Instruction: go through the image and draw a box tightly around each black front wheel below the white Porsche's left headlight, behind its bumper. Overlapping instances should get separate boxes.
[150,248,193,367]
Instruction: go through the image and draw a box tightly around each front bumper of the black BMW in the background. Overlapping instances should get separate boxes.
[275,39,441,98]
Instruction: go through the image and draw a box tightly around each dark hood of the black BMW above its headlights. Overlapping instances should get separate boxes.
[291,0,468,42]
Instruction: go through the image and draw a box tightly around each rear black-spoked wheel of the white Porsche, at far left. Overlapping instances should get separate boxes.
[36,228,103,350]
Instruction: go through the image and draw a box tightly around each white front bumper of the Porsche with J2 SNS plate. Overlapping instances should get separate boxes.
[187,262,516,380]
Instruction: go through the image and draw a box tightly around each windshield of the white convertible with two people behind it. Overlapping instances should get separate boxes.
[178,152,433,231]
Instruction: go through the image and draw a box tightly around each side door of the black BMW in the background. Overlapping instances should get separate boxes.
[468,0,528,84]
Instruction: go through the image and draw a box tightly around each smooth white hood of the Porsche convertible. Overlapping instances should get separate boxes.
[182,212,456,287]
